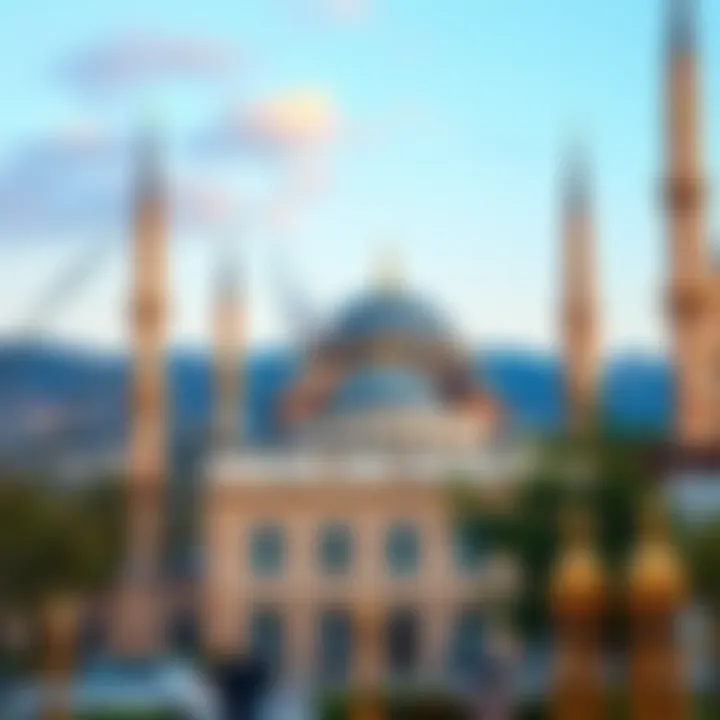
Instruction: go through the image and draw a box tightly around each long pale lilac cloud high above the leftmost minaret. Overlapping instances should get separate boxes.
[66,31,238,91]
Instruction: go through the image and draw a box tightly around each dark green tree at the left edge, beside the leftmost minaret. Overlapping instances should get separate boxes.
[0,475,122,717]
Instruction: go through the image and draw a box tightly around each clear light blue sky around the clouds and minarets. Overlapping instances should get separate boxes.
[0,0,720,350]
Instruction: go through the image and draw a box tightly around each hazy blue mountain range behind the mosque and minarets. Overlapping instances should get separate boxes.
[0,345,671,466]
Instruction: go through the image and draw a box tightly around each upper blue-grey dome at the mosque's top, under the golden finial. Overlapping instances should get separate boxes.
[333,291,448,341]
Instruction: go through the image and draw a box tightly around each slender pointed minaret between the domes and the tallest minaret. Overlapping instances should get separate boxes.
[561,150,599,432]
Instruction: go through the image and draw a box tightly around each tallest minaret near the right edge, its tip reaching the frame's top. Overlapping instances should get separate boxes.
[665,0,714,448]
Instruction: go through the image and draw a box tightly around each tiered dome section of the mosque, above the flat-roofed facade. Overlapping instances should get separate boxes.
[281,258,500,450]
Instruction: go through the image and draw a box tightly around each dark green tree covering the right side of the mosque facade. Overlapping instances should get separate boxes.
[459,433,651,639]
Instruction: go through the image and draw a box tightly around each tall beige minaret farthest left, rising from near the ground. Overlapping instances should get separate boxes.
[115,126,167,656]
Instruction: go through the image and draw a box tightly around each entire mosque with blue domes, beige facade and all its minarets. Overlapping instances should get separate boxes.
[116,0,715,696]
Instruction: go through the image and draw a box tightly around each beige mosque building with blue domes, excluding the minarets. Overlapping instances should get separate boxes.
[203,262,527,682]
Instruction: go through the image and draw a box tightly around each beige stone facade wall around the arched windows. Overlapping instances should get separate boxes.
[202,479,507,676]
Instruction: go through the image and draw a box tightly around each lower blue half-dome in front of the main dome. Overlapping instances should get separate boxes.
[331,367,438,412]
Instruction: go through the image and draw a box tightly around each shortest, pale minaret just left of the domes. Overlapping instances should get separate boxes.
[212,245,244,451]
